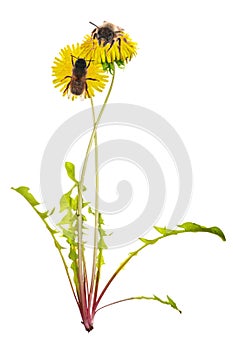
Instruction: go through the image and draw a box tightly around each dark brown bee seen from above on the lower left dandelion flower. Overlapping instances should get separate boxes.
[63,55,97,96]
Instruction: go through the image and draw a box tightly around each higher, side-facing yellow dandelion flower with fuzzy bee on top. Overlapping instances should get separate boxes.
[81,22,137,71]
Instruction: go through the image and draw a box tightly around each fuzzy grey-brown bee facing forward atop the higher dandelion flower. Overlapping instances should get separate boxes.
[89,21,124,49]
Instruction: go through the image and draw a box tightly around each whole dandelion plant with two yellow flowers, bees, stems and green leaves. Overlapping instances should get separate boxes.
[13,22,225,332]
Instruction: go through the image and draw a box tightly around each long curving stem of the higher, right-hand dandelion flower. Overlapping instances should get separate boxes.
[77,68,115,326]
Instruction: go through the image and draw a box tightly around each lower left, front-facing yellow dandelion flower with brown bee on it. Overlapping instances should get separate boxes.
[52,44,108,100]
